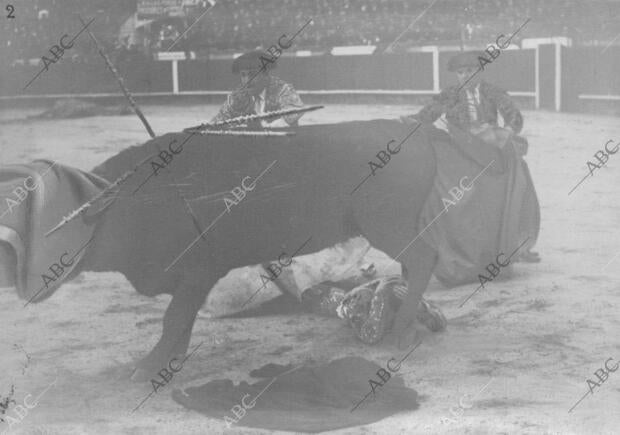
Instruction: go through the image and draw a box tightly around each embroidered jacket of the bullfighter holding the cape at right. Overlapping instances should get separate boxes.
[411,81,523,133]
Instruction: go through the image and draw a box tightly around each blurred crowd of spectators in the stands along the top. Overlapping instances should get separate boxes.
[1,0,620,60]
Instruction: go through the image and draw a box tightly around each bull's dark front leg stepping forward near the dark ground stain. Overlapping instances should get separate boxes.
[131,276,215,381]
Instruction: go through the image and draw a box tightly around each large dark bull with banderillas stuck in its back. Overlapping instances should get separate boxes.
[43,120,436,375]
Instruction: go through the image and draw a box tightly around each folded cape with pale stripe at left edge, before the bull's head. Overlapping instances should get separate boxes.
[0,161,108,302]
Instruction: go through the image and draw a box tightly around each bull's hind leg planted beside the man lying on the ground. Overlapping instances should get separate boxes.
[393,238,446,347]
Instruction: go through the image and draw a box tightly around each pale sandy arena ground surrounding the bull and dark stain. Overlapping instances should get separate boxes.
[0,100,620,434]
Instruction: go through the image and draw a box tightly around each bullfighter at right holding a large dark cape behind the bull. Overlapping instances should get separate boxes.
[402,52,540,286]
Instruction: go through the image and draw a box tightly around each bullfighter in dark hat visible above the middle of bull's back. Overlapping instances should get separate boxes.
[211,51,303,127]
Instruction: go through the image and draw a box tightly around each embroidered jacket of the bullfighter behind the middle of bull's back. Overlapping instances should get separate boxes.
[211,76,303,125]
